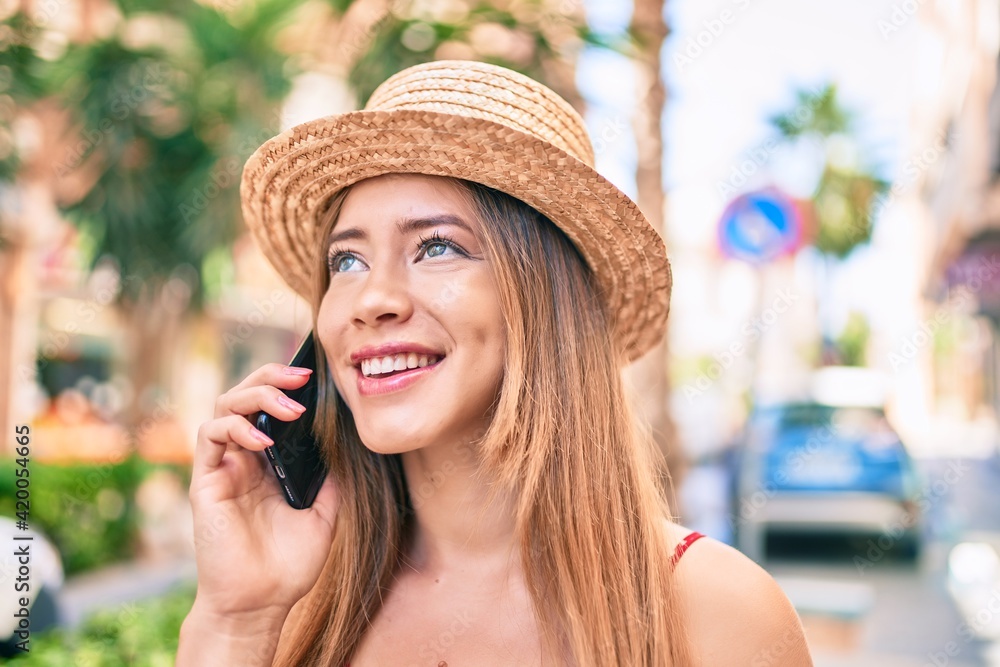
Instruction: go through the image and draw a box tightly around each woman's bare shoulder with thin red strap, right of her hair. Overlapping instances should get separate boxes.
[666,521,812,667]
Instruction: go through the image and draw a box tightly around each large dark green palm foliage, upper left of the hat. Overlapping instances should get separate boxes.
[55,0,300,306]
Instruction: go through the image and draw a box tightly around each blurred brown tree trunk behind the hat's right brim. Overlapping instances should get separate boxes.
[626,0,686,515]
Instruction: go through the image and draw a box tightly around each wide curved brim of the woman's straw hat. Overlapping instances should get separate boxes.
[240,109,672,361]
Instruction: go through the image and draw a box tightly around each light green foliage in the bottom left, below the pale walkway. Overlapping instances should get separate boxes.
[16,584,195,667]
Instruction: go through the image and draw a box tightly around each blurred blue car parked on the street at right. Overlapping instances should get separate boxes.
[733,402,922,562]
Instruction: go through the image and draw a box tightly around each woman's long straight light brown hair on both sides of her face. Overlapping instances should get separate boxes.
[275,181,688,667]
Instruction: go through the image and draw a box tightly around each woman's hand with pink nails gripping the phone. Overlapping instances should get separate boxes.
[190,364,340,619]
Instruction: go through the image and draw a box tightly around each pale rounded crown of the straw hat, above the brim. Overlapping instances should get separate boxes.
[365,60,594,168]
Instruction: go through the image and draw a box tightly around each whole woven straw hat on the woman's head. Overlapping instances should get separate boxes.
[240,60,671,360]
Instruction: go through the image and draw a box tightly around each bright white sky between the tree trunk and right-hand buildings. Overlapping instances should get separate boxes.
[665,0,918,247]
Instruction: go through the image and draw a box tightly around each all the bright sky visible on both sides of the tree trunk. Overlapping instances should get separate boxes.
[578,0,936,342]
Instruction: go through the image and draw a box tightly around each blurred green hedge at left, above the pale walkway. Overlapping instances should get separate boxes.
[0,456,189,575]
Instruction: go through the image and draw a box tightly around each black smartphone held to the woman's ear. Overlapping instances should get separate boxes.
[254,332,327,509]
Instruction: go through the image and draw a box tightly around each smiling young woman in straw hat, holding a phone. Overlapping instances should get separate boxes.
[177,61,812,667]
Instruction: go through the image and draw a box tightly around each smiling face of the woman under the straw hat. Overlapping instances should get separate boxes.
[317,174,505,454]
